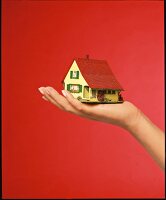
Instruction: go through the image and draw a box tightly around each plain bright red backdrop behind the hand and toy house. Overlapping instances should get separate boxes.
[2,0,164,198]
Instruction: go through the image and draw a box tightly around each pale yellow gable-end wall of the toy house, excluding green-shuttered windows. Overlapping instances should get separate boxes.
[64,60,89,99]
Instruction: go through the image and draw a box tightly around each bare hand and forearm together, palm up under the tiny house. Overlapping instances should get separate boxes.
[38,86,165,170]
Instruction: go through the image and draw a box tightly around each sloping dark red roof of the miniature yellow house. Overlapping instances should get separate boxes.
[63,58,123,90]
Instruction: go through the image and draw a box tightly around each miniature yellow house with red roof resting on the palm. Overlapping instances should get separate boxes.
[62,56,123,103]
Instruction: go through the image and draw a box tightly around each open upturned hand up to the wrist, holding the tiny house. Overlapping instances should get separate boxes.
[39,87,141,128]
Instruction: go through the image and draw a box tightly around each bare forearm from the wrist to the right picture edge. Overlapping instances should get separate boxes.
[126,112,165,169]
